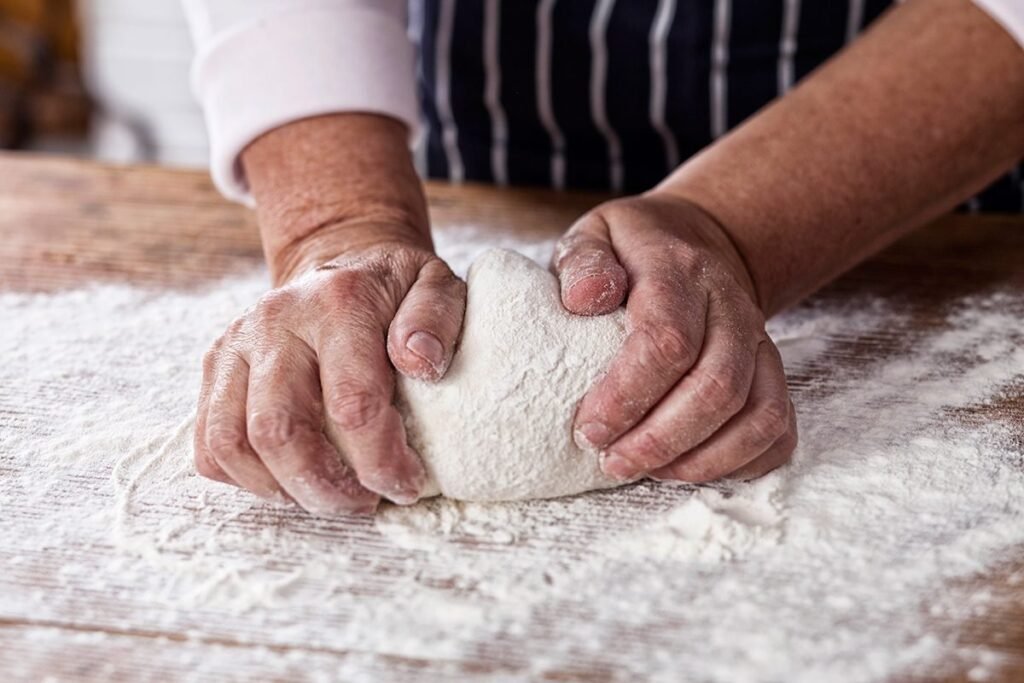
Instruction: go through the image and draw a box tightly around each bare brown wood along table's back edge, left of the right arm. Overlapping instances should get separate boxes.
[0,154,601,291]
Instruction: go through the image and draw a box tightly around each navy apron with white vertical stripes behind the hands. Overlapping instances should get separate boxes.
[410,0,1024,212]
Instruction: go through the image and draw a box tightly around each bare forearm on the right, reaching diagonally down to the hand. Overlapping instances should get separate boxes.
[658,0,1024,314]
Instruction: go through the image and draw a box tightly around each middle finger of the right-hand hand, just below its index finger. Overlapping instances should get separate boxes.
[602,299,761,479]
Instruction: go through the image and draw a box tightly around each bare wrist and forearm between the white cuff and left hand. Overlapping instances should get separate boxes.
[241,114,431,283]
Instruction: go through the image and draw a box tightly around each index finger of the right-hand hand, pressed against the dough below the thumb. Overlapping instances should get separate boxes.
[573,256,707,450]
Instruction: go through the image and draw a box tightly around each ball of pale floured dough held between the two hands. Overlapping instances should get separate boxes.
[398,250,626,501]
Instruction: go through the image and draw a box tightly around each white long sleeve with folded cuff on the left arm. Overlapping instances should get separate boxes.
[183,0,418,204]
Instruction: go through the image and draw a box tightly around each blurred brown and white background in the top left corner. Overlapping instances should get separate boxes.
[0,0,207,167]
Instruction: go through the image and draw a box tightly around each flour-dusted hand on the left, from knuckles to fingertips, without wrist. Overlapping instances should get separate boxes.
[196,232,465,515]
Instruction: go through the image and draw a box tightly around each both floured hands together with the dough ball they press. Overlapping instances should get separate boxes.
[195,210,796,515]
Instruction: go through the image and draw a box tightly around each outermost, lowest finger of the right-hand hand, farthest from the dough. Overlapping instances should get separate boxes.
[652,341,796,483]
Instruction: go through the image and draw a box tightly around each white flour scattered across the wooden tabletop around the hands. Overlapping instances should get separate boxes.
[0,228,1024,681]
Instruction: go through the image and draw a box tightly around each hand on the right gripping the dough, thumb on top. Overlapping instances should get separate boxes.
[553,193,797,482]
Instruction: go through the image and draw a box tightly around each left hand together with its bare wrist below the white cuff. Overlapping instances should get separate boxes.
[196,113,466,515]
